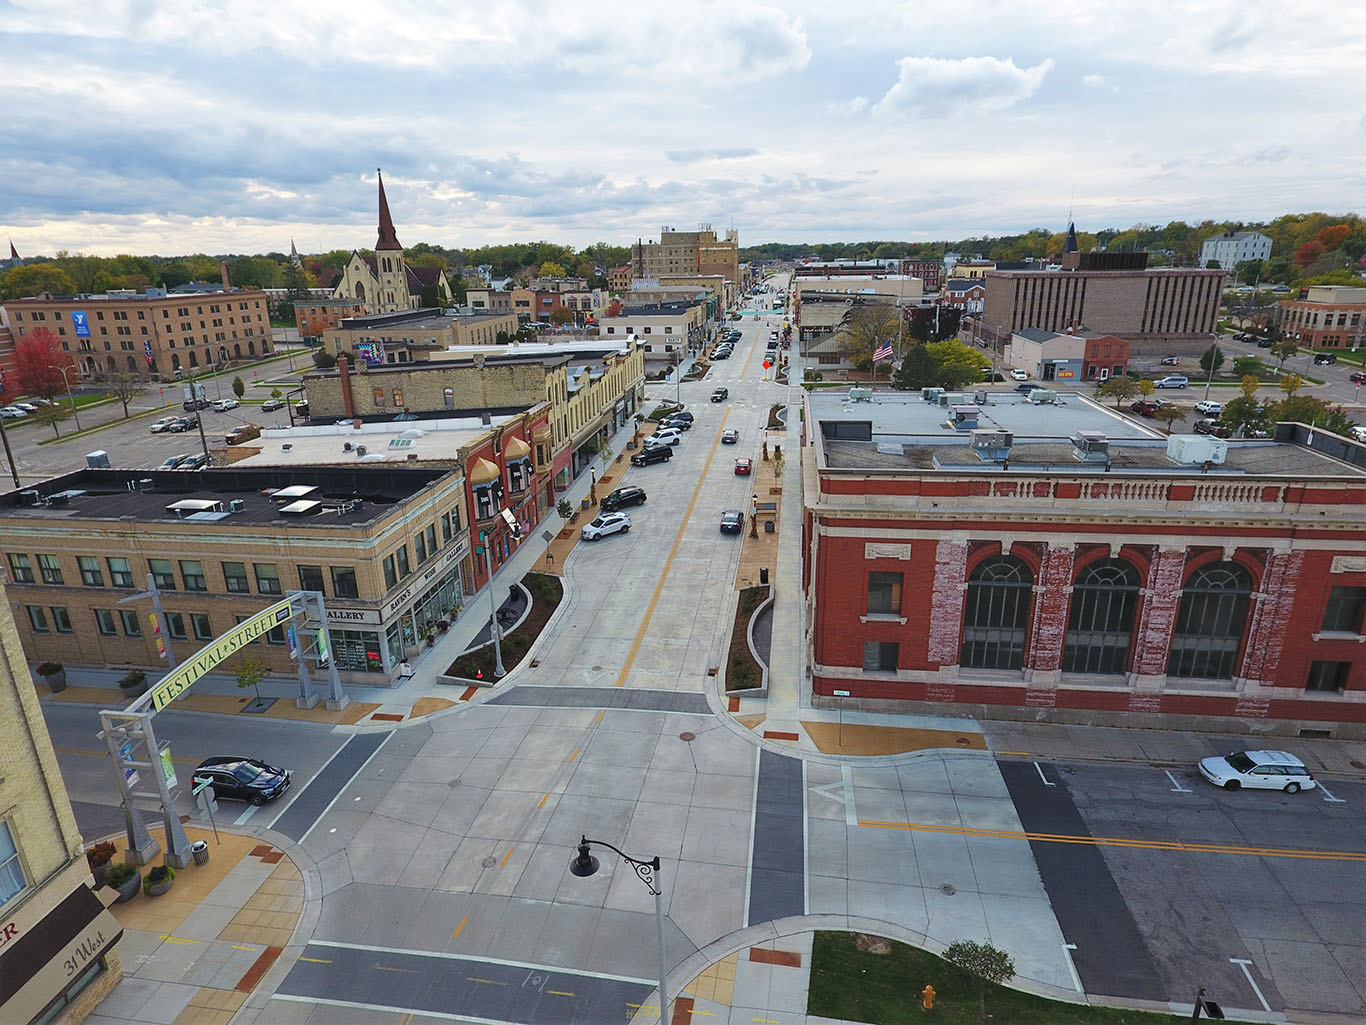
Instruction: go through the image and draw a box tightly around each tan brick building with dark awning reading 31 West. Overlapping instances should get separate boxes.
[0,589,123,1025]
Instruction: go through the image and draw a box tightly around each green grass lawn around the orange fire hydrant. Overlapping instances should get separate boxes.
[806,932,1188,1025]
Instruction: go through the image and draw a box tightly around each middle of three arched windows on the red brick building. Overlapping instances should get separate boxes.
[1063,559,1138,672]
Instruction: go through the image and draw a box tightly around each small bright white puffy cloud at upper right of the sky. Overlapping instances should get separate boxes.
[872,57,1053,120]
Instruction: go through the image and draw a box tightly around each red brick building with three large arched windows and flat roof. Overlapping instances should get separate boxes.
[803,392,1366,737]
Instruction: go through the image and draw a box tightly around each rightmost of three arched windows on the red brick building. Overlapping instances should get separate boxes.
[1167,562,1253,679]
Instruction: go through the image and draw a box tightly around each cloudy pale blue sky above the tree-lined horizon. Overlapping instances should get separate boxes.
[0,0,1366,256]
